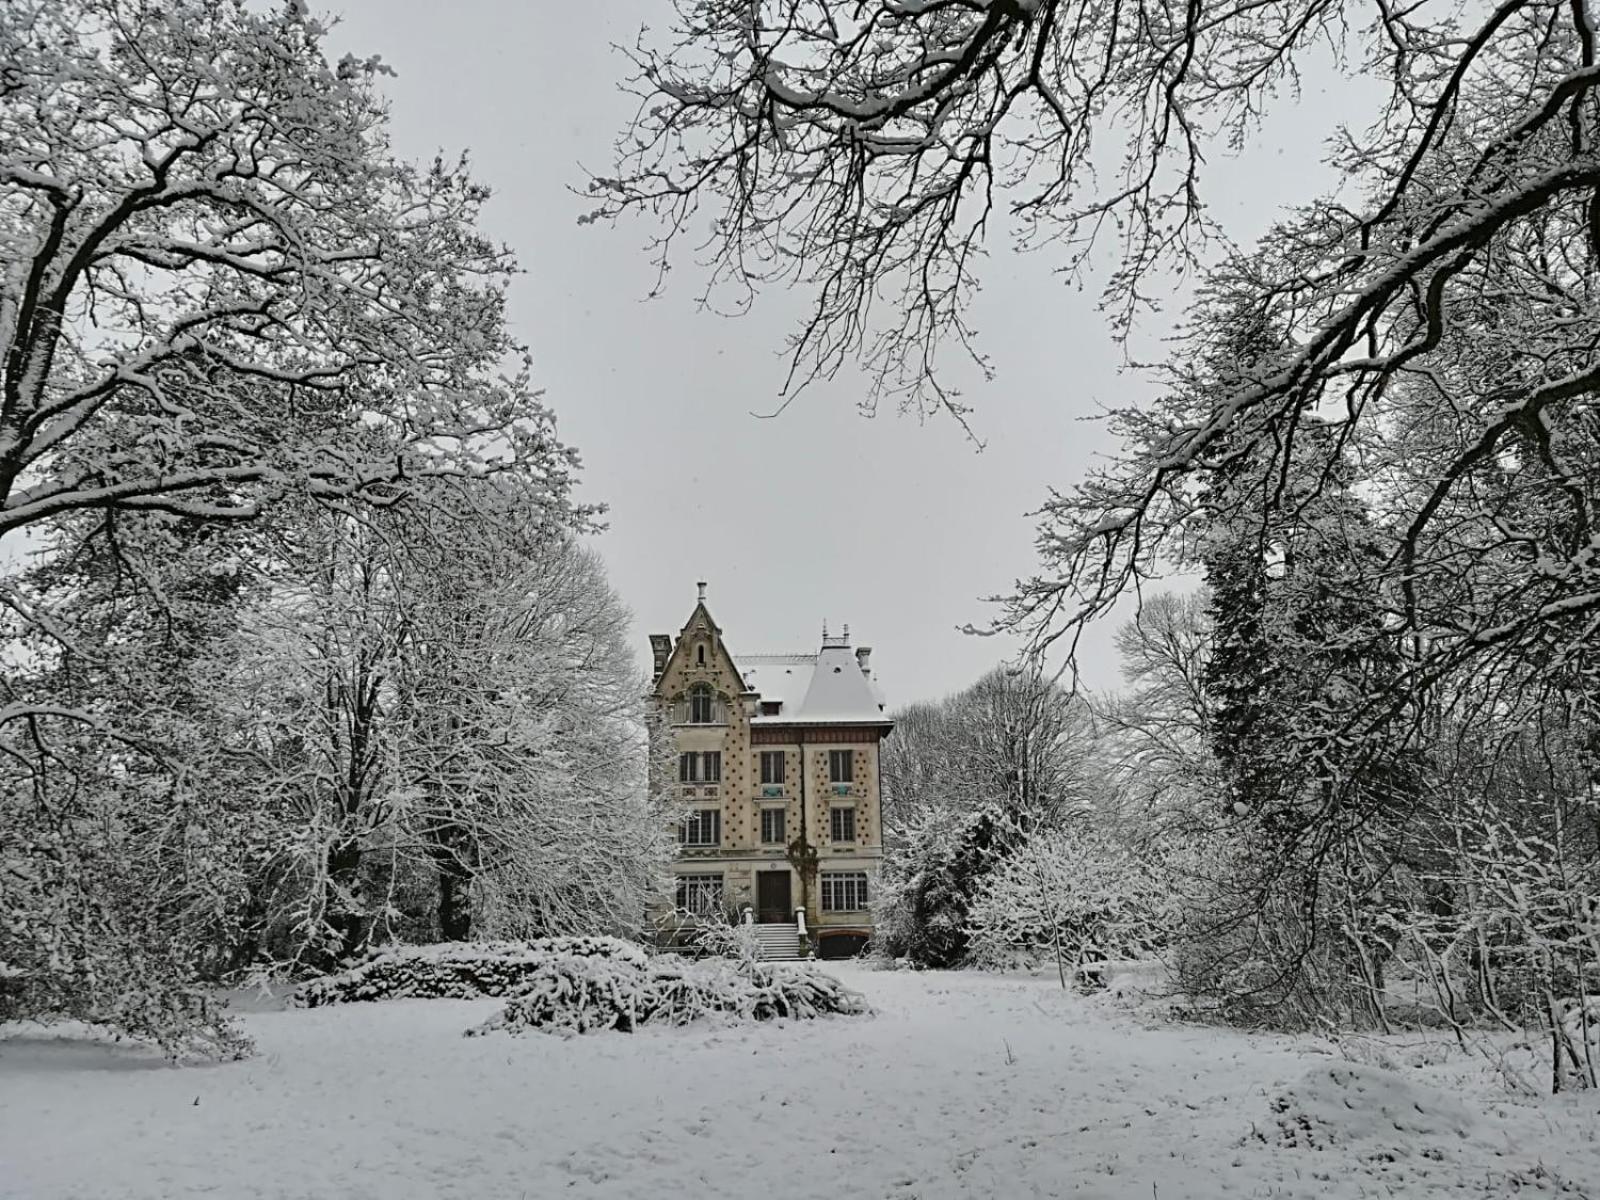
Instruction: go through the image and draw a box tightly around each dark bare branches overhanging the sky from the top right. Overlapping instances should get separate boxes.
[592,0,1600,732]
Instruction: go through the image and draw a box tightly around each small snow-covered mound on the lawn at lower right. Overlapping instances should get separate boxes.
[1256,1062,1478,1162]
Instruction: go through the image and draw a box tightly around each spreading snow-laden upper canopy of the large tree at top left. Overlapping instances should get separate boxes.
[0,0,573,547]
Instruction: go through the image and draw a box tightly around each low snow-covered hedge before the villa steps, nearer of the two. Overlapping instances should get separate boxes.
[467,955,869,1034]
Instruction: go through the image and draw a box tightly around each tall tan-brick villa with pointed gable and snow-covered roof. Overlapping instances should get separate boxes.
[650,582,893,958]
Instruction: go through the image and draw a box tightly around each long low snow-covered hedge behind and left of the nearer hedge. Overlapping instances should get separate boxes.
[294,938,650,1008]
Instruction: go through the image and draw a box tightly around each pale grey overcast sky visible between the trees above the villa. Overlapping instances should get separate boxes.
[325,0,1356,706]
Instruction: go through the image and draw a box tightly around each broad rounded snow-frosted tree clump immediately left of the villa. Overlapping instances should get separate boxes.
[193,477,670,963]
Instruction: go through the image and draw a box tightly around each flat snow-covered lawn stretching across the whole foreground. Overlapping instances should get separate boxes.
[0,965,1600,1200]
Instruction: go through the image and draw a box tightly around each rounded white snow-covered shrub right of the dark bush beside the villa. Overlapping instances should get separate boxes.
[966,830,1176,979]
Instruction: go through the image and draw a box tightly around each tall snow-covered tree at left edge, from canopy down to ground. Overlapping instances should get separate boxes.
[0,0,588,1045]
